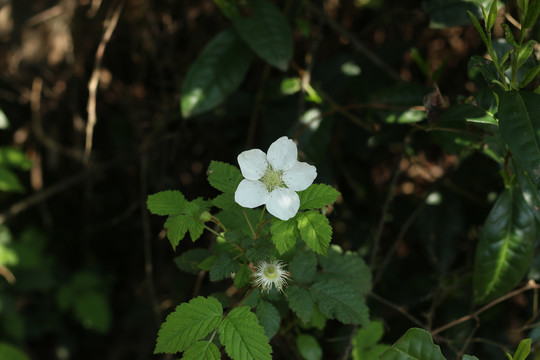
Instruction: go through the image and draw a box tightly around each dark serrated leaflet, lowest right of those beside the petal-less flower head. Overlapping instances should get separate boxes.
[309,279,369,326]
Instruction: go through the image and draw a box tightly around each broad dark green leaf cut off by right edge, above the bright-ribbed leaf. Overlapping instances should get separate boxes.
[497,91,540,185]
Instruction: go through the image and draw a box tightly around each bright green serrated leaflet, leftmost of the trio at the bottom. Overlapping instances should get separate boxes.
[154,296,223,354]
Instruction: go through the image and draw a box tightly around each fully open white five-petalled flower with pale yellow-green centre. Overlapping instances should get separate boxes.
[234,136,317,220]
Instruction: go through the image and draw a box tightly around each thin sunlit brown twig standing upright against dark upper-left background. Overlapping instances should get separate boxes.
[83,0,125,163]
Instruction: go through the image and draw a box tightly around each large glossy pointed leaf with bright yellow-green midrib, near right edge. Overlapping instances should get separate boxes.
[473,188,536,302]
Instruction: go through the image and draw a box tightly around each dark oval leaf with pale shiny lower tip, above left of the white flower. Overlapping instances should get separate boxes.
[181,29,252,118]
